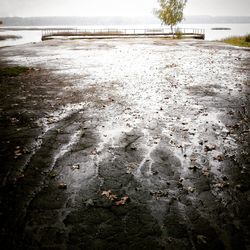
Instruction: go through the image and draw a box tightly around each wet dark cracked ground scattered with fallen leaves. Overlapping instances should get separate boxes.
[0,39,250,250]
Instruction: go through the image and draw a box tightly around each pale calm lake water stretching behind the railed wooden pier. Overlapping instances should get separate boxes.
[0,23,249,47]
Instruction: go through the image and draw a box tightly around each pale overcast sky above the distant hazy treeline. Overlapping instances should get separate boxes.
[0,0,250,17]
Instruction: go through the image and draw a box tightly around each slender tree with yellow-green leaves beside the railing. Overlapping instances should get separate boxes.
[155,0,187,37]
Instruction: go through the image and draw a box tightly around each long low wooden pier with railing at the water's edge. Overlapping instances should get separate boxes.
[42,28,205,40]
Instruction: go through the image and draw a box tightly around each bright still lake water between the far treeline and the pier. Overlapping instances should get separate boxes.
[0,23,250,47]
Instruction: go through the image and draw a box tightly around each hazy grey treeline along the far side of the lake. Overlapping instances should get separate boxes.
[0,16,250,26]
